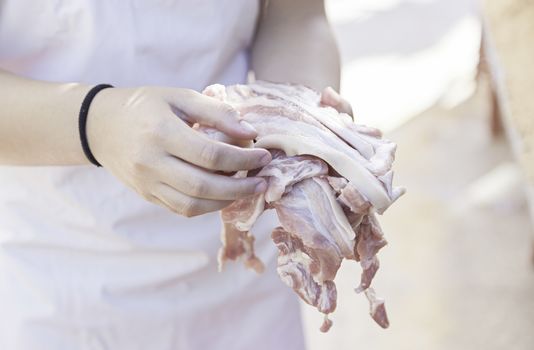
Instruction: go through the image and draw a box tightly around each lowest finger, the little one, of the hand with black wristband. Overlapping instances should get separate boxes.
[153,182,232,217]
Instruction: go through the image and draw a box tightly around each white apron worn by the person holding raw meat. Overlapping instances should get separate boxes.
[0,0,304,350]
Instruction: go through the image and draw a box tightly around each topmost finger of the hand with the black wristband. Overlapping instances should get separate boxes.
[169,91,258,140]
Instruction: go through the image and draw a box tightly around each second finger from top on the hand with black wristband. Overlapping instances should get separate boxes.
[164,123,271,172]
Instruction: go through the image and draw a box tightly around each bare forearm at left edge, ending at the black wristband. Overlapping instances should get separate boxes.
[0,70,90,165]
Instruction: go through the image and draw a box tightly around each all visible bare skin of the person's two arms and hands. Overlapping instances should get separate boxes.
[0,0,351,217]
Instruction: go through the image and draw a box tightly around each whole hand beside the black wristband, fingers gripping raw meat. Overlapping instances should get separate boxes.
[87,87,271,217]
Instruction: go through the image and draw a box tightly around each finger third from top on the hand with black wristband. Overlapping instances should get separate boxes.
[158,156,267,200]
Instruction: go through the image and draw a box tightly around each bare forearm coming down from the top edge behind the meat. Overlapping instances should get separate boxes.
[252,0,340,91]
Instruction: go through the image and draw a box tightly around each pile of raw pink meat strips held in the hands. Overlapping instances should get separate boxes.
[204,82,404,332]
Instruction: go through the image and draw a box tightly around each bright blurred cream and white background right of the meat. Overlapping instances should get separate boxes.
[303,0,534,350]
